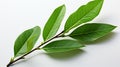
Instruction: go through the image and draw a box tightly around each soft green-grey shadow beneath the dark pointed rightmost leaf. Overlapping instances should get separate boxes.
[85,32,116,45]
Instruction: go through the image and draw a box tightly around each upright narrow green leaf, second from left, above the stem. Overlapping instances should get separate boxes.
[43,5,66,41]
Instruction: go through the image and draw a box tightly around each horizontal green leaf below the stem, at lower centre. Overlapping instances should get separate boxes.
[43,39,84,53]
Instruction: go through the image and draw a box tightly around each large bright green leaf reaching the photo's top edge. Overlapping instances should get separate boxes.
[64,0,104,33]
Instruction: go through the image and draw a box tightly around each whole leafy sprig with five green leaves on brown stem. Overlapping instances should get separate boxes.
[7,0,116,67]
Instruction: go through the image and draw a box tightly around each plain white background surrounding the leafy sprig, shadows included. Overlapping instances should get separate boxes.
[0,0,120,67]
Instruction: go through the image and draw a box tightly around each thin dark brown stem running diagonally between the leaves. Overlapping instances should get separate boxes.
[7,31,64,67]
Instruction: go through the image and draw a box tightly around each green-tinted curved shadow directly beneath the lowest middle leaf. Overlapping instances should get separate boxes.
[46,49,85,60]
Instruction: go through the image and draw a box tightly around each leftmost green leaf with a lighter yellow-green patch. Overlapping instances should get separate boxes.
[14,26,40,57]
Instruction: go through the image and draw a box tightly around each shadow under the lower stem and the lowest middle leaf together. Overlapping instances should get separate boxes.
[11,49,85,66]
